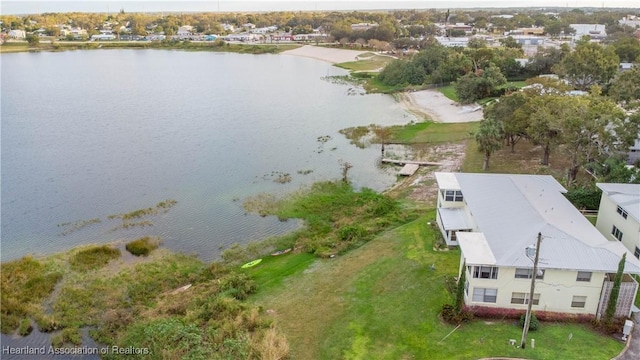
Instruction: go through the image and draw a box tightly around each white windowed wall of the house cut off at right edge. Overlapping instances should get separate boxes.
[596,192,640,254]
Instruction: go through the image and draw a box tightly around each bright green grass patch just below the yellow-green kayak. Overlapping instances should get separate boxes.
[242,253,317,295]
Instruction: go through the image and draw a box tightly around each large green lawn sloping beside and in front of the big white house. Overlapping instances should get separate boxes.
[252,211,623,359]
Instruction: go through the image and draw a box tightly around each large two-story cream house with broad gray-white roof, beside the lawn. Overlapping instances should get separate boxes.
[435,173,640,317]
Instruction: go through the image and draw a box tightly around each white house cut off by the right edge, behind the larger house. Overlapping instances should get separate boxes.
[596,183,640,259]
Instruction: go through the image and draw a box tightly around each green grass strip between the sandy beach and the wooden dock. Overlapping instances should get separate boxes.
[390,122,479,144]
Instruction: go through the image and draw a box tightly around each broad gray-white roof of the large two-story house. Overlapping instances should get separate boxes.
[455,173,640,273]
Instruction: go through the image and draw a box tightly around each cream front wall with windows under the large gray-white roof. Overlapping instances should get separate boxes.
[465,264,605,315]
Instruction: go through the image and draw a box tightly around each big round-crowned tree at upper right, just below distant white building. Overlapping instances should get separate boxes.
[553,42,620,90]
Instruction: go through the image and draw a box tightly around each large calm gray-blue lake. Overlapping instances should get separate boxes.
[0,50,414,261]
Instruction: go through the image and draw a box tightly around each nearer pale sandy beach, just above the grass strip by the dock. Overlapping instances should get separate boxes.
[400,90,483,123]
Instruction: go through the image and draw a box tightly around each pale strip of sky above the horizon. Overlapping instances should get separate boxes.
[0,0,640,15]
